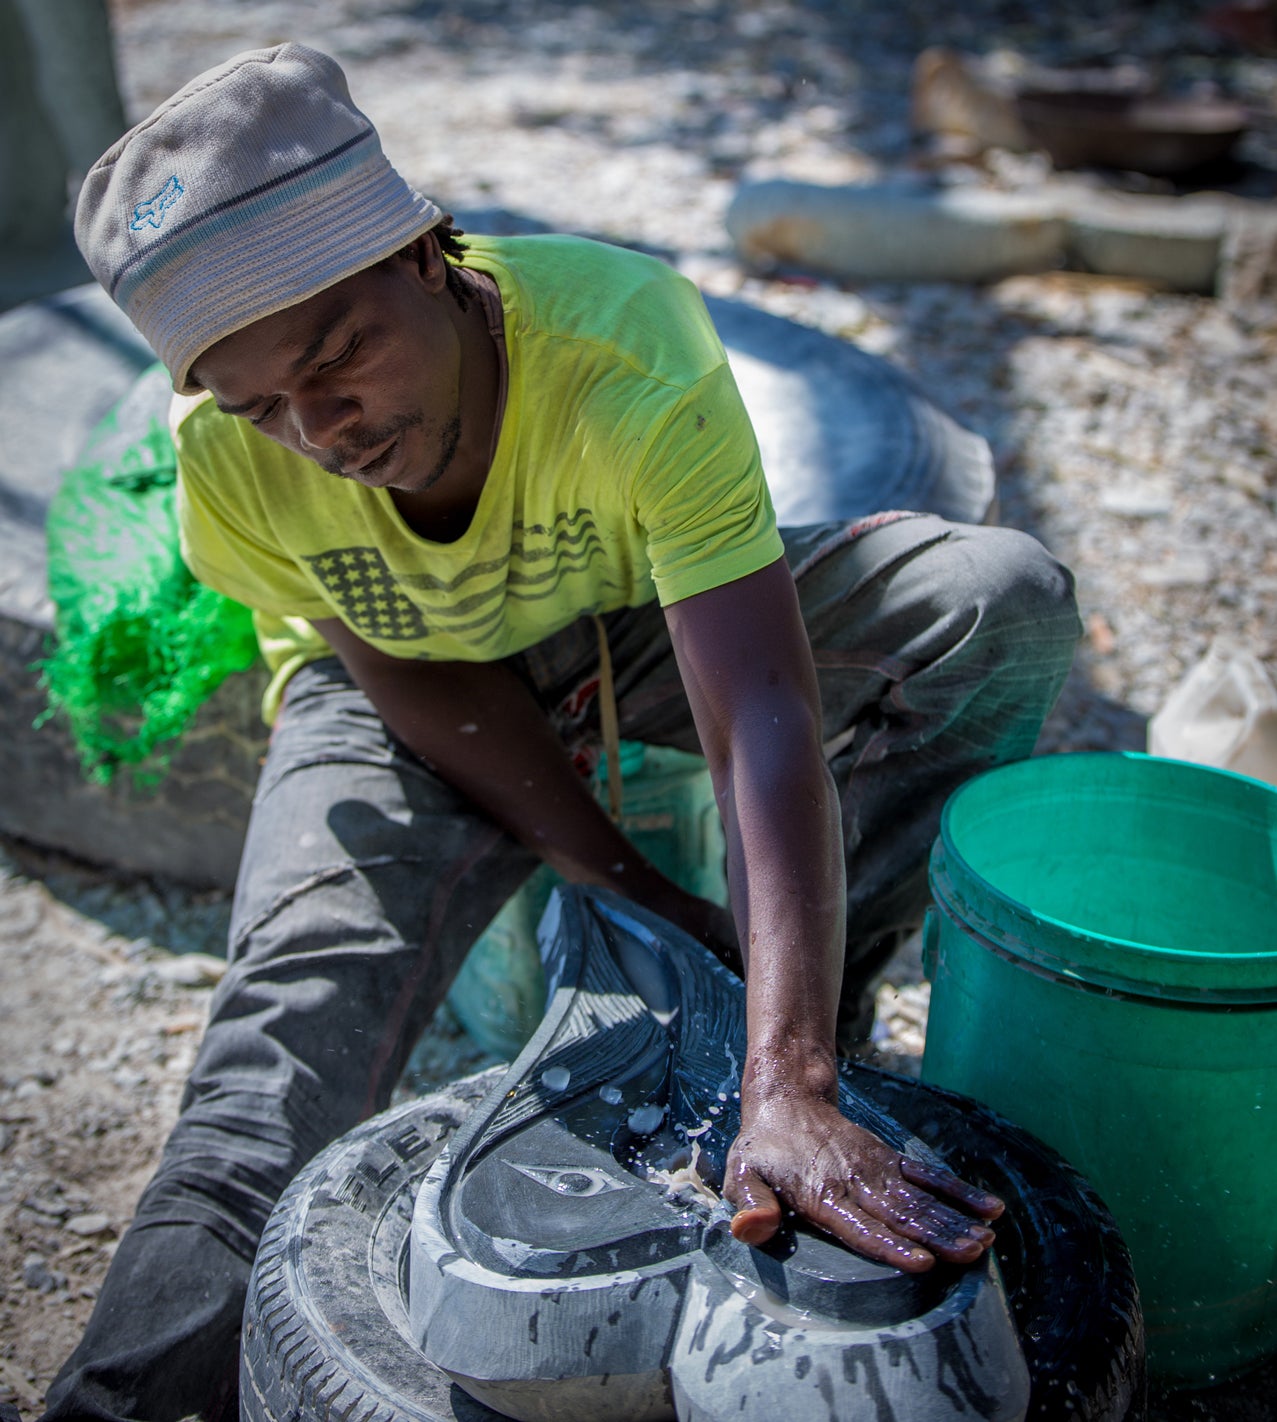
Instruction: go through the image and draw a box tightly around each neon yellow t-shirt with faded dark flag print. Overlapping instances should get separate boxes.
[173,236,784,714]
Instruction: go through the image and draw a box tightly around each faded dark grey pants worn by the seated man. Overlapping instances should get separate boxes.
[39,515,1078,1422]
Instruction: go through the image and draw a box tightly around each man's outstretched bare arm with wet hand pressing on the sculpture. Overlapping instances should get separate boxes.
[666,562,1003,1271]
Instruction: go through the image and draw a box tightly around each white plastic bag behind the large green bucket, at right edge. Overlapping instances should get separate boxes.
[1149,637,1277,785]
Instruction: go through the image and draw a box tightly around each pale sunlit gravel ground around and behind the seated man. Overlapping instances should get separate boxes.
[0,0,1277,1422]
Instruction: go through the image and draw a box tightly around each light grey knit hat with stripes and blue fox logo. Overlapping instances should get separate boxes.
[75,44,442,394]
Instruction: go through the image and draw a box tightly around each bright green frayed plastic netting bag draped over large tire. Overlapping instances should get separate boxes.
[41,365,257,784]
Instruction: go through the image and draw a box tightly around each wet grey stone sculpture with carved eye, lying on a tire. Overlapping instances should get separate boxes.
[408,889,1030,1422]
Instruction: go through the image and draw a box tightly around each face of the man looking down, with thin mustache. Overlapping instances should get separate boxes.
[192,235,462,492]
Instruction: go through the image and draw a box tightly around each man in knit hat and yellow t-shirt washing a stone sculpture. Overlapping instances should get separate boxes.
[48,46,1078,1419]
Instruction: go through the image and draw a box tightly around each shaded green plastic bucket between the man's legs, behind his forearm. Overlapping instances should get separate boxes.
[448,741,727,1059]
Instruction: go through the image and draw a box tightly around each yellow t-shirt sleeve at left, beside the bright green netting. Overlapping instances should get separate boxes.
[173,403,333,617]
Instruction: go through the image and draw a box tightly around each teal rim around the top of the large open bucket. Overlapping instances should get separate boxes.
[930,751,1277,1005]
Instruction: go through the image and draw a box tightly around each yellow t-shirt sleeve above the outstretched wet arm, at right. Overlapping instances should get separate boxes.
[634,363,785,607]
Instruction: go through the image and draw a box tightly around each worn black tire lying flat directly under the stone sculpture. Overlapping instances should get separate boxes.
[240,1067,1146,1422]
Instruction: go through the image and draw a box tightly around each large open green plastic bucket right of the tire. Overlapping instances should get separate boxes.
[923,754,1277,1386]
